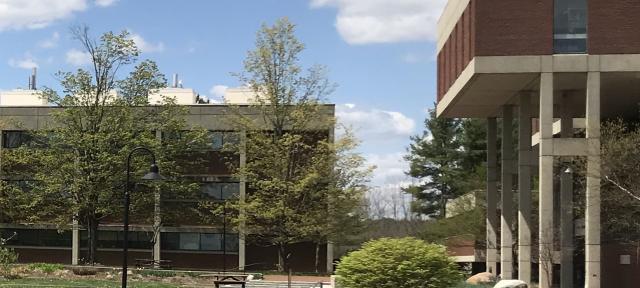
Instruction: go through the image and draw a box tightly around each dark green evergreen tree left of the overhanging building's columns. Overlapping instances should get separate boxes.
[405,109,486,218]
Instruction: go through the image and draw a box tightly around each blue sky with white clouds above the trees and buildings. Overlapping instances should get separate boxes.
[0,0,446,185]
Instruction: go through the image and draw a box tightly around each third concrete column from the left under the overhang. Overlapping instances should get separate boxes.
[518,94,531,283]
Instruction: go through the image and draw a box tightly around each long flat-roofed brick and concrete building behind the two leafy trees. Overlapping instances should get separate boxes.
[0,81,334,272]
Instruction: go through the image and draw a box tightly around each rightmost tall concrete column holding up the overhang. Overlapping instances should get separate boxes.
[585,72,601,288]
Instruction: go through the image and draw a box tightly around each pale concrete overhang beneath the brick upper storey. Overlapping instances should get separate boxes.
[437,54,640,118]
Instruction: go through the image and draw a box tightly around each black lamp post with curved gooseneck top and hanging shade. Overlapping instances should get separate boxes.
[122,147,163,288]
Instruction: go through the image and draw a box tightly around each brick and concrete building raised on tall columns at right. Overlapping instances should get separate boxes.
[437,0,640,288]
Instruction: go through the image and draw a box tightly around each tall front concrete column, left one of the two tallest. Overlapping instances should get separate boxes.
[538,73,553,288]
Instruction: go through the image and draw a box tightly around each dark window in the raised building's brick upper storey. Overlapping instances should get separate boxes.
[553,0,587,54]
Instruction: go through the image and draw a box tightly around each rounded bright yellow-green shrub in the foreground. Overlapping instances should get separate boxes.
[336,238,462,288]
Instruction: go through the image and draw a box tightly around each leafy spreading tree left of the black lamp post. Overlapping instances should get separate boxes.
[2,27,205,264]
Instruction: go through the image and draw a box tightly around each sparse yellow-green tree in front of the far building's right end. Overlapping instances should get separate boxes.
[220,19,370,271]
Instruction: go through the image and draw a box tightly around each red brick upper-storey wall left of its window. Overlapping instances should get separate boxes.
[438,0,556,101]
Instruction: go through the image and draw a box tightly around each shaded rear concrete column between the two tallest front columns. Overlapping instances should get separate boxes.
[560,95,574,287]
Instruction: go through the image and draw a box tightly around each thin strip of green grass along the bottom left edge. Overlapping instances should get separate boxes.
[0,279,180,288]
